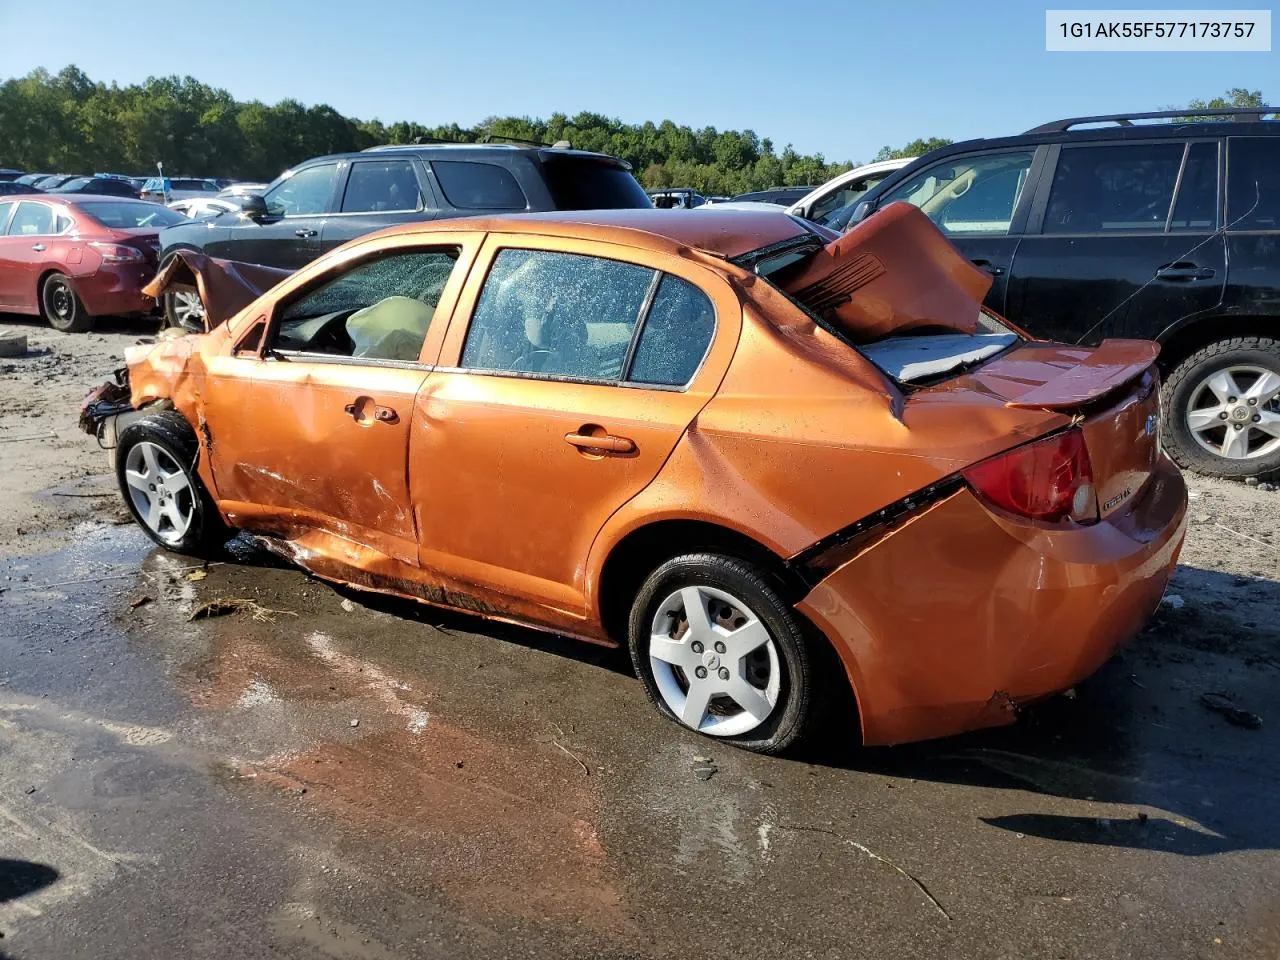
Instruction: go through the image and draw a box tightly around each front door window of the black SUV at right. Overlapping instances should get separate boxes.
[878,150,1034,237]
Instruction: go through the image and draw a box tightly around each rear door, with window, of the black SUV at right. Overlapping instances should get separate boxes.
[1007,140,1226,343]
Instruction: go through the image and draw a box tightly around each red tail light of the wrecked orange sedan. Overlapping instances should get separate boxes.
[963,429,1098,524]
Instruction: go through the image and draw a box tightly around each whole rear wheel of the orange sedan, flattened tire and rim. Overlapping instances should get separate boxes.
[628,553,819,754]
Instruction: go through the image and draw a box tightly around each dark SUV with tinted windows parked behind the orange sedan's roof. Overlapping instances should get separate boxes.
[160,143,653,309]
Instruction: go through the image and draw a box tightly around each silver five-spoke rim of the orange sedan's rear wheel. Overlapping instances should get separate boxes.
[649,586,782,736]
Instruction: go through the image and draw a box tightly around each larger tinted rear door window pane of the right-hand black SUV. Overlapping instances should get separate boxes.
[1043,143,1185,233]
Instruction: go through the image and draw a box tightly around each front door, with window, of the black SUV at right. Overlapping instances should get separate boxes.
[874,146,1047,314]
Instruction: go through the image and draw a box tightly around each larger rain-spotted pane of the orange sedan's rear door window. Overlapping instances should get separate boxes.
[461,250,654,380]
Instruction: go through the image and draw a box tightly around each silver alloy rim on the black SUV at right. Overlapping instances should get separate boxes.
[1187,365,1280,460]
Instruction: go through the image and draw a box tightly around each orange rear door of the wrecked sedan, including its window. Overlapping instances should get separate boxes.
[410,237,740,622]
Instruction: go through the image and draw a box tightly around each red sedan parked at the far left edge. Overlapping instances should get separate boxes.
[0,193,186,333]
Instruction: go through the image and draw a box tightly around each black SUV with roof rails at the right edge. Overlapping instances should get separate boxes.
[851,106,1280,477]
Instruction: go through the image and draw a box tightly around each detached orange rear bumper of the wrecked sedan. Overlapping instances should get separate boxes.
[799,456,1187,744]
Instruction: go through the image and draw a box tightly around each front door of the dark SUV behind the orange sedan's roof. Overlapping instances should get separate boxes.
[320,157,439,252]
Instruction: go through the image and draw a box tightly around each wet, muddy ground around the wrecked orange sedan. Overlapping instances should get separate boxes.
[0,317,1280,960]
